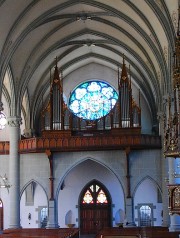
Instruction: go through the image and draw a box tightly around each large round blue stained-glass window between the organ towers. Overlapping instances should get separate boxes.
[69,81,118,120]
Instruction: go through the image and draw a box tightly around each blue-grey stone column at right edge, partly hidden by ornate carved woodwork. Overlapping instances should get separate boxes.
[169,158,180,231]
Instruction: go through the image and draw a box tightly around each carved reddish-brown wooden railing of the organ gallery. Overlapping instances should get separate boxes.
[0,135,161,154]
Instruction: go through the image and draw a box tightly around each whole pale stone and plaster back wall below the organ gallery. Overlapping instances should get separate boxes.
[0,150,163,228]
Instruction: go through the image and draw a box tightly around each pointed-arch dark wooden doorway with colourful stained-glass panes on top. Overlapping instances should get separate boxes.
[80,180,111,234]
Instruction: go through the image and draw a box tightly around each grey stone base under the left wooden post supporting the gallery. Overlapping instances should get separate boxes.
[46,200,59,229]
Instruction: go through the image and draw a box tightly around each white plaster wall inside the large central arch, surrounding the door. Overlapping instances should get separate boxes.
[58,159,125,227]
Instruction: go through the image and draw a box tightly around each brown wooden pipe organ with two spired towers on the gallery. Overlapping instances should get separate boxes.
[42,58,141,138]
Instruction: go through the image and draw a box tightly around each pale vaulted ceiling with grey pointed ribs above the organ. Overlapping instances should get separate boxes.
[0,0,178,130]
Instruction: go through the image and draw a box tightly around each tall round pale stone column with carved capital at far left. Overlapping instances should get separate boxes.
[8,117,21,229]
